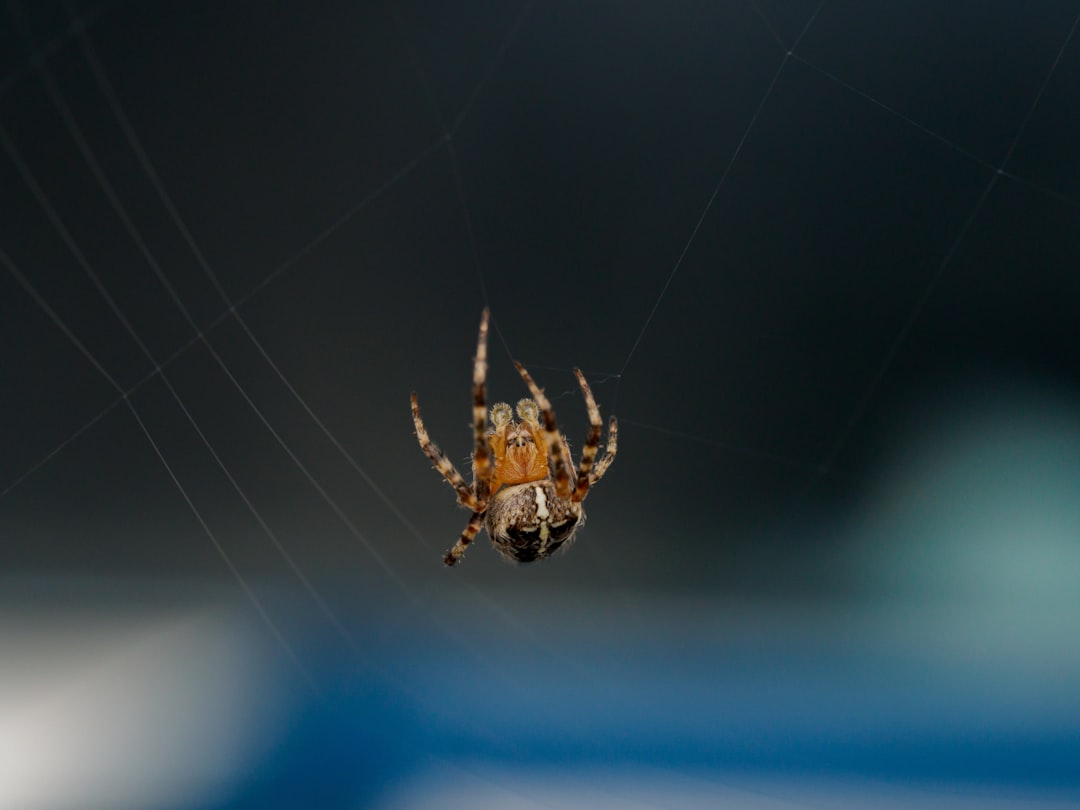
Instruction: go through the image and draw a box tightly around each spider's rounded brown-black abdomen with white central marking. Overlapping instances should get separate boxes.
[485,478,585,563]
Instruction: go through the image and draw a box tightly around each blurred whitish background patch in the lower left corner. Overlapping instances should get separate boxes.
[0,583,289,810]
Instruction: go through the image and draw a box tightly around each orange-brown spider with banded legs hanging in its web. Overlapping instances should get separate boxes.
[413,309,619,565]
